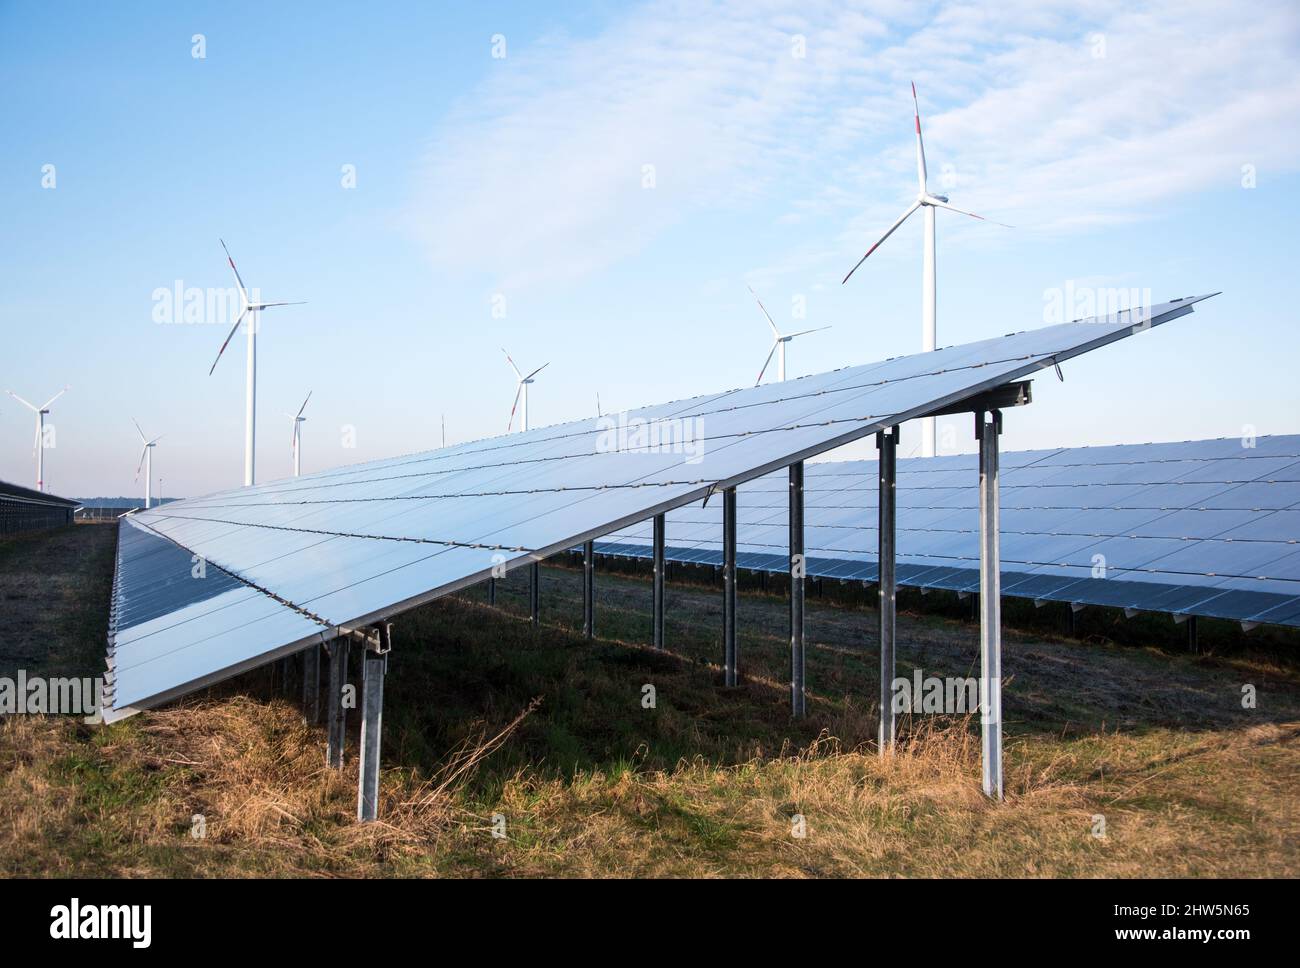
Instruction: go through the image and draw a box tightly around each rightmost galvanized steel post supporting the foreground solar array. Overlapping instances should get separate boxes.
[975,411,1002,800]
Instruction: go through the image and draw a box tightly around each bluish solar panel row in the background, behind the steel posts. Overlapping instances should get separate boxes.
[597,435,1300,626]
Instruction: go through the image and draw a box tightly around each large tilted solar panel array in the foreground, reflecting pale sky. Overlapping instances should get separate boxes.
[111,296,1206,715]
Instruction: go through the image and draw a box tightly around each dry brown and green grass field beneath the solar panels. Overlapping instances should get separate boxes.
[0,525,1300,877]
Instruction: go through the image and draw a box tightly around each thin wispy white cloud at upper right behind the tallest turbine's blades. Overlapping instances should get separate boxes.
[413,0,1300,287]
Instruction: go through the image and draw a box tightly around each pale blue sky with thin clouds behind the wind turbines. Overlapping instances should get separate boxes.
[0,0,1300,495]
